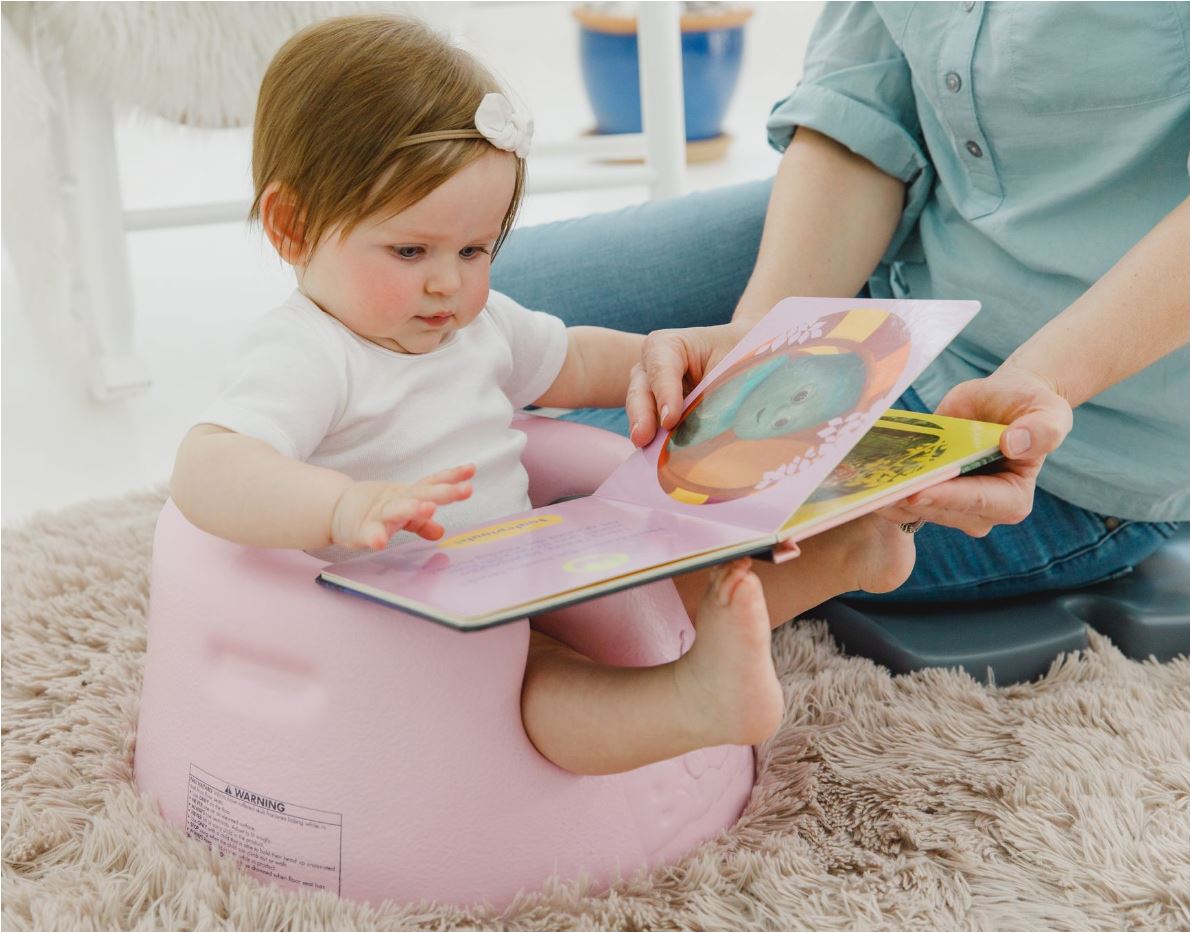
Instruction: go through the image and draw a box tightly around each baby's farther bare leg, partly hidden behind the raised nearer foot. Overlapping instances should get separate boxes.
[674,515,915,629]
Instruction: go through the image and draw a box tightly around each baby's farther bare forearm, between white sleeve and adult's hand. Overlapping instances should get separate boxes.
[535,326,646,409]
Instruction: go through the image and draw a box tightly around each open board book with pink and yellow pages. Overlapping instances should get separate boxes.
[318,298,1003,630]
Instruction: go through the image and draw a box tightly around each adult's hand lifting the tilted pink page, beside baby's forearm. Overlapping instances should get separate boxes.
[624,322,752,447]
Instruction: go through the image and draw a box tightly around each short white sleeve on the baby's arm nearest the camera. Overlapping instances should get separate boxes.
[199,306,347,460]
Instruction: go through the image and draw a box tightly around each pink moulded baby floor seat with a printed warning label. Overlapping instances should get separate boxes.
[136,416,753,907]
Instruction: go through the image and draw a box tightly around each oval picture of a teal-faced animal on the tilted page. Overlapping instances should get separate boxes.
[657,307,910,505]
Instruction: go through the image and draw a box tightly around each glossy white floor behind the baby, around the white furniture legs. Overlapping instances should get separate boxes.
[0,1,821,525]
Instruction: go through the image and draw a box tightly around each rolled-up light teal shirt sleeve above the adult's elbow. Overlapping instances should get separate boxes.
[767,2,935,261]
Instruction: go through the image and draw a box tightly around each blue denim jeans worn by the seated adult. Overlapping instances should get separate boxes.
[492,181,1186,602]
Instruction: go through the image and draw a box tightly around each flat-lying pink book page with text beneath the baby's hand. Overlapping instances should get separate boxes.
[322,497,752,617]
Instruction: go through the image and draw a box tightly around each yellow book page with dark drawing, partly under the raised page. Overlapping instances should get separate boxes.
[779,409,1004,537]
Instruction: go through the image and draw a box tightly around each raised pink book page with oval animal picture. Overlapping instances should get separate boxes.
[596,298,980,534]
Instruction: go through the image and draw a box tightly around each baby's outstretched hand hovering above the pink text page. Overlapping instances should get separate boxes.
[331,464,475,551]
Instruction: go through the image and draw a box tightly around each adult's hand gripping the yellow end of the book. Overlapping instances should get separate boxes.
[880,363,1072,537]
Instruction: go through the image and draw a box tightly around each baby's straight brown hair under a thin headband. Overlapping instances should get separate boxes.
[250,14,525,260]
